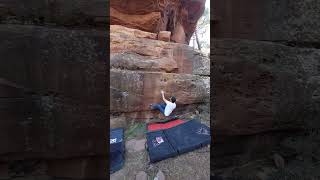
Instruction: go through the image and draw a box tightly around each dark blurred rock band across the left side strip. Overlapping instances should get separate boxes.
[0,25,107,105]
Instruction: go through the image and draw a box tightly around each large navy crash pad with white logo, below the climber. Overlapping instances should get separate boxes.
[147,120,211,163]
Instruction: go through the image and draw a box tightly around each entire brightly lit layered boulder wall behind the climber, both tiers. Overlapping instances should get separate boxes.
[110,26,210,118]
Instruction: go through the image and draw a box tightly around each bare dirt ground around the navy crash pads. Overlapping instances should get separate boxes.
[110,108,210,180]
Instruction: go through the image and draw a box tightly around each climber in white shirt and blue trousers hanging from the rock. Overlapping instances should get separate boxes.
[150,90,176,117]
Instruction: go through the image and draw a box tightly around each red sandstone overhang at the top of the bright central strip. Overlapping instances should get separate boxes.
[110,0,205,44]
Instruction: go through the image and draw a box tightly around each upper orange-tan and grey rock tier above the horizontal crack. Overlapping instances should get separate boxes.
[110,25,210,76]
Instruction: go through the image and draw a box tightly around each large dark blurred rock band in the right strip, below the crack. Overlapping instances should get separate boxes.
[213,40,320,135]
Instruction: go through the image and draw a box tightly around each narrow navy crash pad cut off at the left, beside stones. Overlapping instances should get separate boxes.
[109,128,124,173]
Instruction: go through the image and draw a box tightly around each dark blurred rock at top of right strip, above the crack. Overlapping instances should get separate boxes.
[213,0,320,43]
